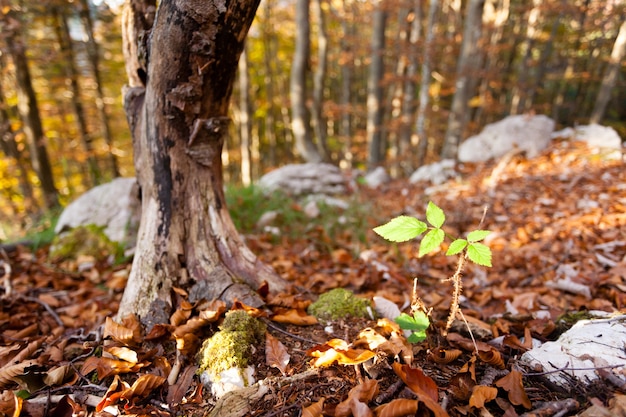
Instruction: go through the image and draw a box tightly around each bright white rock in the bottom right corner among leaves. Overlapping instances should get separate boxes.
[521,313,626,388]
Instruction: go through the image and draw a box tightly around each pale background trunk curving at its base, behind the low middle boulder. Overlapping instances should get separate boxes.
[289,0,322,162]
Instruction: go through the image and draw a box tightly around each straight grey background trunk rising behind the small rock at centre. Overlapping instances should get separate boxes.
[367,0,387,169]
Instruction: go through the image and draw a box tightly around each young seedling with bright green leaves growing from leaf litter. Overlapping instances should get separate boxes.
[374,201,491,343]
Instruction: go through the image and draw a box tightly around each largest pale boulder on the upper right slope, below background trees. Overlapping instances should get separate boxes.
[458,115,554,162]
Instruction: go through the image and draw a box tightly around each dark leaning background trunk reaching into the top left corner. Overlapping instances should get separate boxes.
[0,4,59,209]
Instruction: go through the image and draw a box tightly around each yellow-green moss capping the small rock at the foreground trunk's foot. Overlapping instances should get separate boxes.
[198,310,267,376]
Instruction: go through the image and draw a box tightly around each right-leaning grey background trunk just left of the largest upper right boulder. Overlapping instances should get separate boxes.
[441,0,483,159]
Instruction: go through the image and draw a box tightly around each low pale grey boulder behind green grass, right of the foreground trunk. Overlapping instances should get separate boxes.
[258,163,348,196]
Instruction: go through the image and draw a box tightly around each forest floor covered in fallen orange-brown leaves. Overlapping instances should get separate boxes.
[0,142,626,417]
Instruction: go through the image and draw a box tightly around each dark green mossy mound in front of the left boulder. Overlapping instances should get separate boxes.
[50,224,121,261]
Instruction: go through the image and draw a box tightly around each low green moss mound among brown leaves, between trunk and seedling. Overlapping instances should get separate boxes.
[308,288,374,322]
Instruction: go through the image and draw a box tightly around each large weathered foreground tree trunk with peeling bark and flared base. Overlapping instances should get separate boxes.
[118,0,286,323]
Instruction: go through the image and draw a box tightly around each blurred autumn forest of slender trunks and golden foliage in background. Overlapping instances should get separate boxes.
[0,0,626,240]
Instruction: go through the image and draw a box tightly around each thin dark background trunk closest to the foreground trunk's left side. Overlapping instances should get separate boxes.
[79,0,121,177]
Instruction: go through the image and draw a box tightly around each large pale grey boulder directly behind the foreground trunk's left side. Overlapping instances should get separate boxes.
[54,178,141,247]
